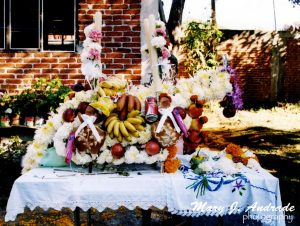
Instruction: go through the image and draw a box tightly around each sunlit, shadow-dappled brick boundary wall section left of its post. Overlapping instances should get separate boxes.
[218,31,272,103]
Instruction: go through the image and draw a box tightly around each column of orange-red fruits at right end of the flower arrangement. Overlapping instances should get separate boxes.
[183,95,208,154]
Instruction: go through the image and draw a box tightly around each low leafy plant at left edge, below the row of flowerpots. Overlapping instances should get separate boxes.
[0,136,28,163]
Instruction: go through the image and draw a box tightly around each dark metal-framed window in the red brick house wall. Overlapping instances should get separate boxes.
[0,0,76,51]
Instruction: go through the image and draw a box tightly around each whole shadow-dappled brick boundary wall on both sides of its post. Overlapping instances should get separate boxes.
[179,30,300,106]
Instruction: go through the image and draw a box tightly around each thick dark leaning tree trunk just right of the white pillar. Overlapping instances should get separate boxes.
[167,0,185,45]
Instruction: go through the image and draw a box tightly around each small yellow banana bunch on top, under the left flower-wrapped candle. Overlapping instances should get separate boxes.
[98,78,127,96]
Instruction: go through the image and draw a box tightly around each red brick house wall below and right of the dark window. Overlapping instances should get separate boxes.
[0,0,141,92]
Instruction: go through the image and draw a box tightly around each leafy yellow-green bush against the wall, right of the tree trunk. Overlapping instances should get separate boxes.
[181,21,223,75]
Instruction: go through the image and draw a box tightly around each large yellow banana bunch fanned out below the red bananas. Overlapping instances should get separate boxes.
[104,110,145,142]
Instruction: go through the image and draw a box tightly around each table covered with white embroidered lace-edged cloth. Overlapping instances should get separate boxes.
[5,155,285,225]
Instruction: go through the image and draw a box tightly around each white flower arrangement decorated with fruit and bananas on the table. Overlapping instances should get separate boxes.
[23,12,237,173]
